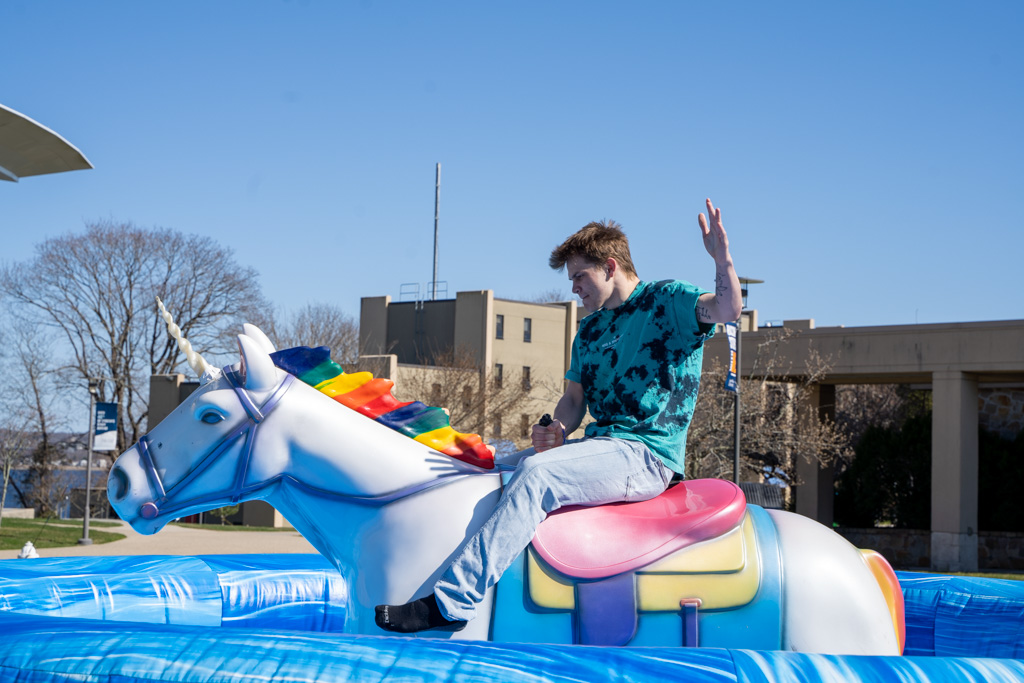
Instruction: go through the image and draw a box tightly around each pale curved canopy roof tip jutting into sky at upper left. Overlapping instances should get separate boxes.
[0,104,92,182]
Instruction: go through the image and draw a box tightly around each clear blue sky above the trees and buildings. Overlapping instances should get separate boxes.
[0,0,1024,326]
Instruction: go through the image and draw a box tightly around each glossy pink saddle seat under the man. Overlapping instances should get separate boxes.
[534,479,746,579]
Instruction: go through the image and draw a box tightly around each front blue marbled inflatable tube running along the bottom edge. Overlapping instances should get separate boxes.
[0,615,1024,683]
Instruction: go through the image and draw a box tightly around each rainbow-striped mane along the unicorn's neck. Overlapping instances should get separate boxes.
[270,346,495,470]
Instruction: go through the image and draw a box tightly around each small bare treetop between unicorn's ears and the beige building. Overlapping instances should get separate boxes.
[264,303,359,369]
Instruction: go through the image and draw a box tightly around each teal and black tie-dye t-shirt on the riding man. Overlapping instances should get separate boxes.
[565,280,715,473]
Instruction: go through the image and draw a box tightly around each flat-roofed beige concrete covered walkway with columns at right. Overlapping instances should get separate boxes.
[705,321,1024,571]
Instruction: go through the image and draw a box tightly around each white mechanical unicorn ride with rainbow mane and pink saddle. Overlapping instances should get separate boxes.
[108,304,904,654]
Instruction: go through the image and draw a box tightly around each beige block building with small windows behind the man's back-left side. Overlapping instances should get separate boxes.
[359,290,578,446]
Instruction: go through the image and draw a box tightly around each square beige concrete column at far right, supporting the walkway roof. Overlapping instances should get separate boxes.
[932,372,978,571]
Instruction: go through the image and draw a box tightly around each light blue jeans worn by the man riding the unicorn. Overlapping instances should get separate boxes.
[434,436,673,621]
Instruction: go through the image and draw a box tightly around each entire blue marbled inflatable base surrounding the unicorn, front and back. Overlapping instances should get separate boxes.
[0,555,1024,683]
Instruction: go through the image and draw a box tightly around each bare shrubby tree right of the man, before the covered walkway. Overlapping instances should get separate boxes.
[686,330,850,485]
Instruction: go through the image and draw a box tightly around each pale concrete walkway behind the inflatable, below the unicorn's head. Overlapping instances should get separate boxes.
[0,522,316,560]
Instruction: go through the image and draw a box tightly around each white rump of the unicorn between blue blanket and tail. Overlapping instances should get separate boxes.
[768,510,900,655]
